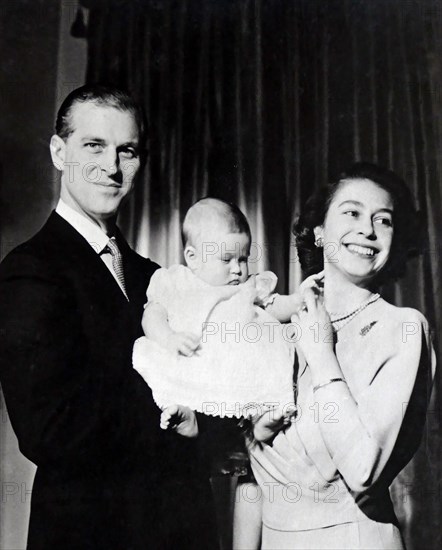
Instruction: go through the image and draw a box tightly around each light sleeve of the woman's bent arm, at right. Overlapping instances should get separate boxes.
[315,310,435,492]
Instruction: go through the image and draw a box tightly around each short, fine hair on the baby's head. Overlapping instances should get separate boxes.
[182,197,252,247]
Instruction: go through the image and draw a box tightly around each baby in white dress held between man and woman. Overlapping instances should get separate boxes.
[134,198,301,418]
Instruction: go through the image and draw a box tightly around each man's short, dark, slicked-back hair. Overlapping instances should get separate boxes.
[55,84,146,142]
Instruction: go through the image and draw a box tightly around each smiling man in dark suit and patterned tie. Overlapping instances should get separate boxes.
[0,86,221,550]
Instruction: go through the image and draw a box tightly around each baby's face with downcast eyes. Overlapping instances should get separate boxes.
[189,233,250,286]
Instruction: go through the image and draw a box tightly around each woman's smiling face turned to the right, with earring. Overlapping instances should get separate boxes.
[315,179,394,283]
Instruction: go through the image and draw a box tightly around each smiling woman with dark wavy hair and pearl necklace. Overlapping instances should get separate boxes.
[251,163,434,550]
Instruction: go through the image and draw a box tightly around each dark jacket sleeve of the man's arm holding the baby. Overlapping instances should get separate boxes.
[0,254,159,468]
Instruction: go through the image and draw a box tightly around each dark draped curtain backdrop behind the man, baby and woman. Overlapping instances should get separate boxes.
[82,0,442,550]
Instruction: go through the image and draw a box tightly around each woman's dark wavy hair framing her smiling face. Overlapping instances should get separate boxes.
[293,162,423,284]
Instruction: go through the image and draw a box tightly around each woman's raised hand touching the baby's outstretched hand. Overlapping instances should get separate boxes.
[291,287,334,365]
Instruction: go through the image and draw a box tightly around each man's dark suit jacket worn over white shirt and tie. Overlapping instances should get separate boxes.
[0,213,221,550]
